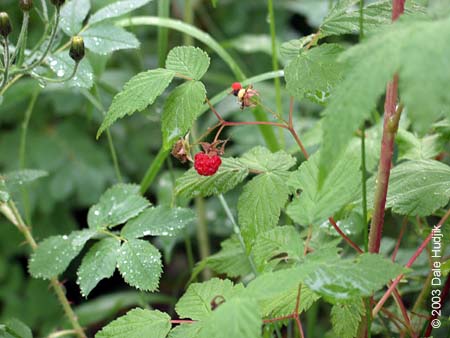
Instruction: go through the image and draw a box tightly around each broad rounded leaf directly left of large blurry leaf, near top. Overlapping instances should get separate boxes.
[285,44,344,99]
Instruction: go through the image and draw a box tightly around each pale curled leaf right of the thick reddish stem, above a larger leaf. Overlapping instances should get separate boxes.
[395,129,444,161]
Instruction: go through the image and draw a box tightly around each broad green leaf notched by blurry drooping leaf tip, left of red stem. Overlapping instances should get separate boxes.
[287,149,361,225]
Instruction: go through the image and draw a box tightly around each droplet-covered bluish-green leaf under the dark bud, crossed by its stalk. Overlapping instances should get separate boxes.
[47,52,94,89]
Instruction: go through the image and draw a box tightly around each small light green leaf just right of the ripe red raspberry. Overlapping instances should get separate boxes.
[239,146,296,172]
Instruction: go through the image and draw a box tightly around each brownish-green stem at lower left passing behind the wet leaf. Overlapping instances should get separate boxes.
[2,200,86,338]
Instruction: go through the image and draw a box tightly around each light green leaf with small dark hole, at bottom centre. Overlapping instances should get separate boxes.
[175,278,243,320]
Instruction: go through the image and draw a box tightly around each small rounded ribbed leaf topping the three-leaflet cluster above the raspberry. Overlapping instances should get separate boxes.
[166,46,209,80]
